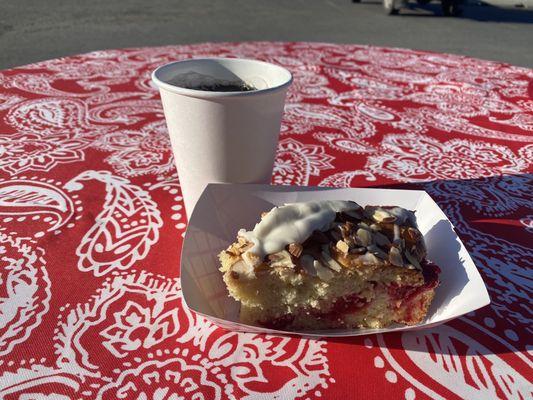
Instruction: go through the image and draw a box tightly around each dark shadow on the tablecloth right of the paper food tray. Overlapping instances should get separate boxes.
[325,173,533,357]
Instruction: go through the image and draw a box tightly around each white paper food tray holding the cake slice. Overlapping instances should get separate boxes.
[181,184,490,337]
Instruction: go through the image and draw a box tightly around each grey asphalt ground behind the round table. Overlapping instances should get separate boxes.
[0,0,533,69]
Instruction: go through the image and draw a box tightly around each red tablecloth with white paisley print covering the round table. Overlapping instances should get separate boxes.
[0,43,533,400]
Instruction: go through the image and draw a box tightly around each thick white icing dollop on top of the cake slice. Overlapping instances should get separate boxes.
[239,201,360,259]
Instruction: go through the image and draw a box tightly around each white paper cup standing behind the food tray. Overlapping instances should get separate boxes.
[152,58,292,216]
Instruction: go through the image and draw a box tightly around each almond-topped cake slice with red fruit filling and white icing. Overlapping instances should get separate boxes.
[219,201,440,330]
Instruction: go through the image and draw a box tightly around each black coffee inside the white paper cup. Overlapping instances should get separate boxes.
[168,72,257,92]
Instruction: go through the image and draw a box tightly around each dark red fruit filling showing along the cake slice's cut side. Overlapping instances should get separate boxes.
[259,262,440,330]
